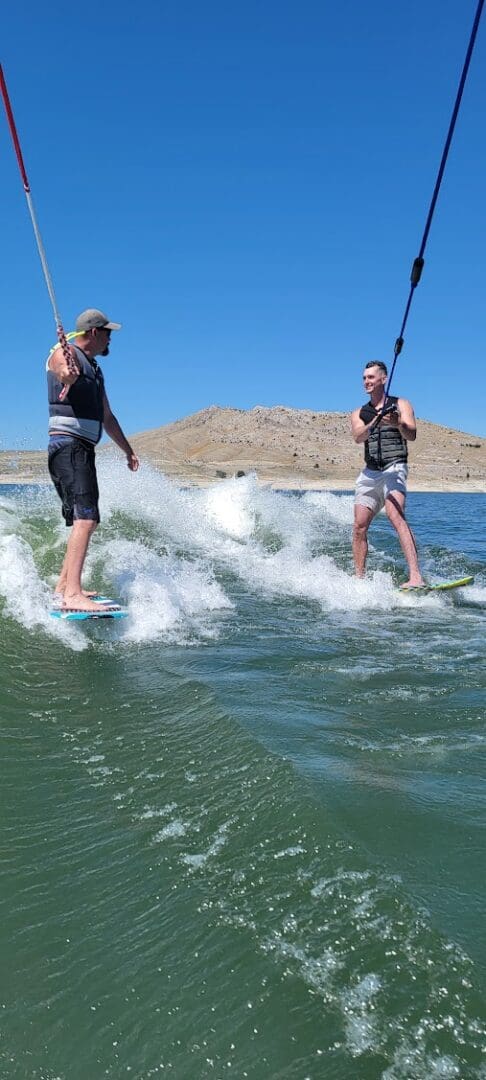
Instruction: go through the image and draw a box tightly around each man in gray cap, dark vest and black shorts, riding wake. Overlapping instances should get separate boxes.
[46,308,139,611]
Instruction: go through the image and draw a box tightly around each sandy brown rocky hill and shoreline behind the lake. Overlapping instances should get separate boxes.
[0,405,486,491]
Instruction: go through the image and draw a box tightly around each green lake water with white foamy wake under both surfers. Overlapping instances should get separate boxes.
[0,461,486,1080]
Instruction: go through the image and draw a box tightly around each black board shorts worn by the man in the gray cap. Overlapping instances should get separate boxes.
[48,435,99,526]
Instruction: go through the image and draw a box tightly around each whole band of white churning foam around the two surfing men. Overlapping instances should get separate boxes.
[0,464,477,649]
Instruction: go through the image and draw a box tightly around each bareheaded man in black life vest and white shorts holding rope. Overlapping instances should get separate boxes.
[351,361,423,588]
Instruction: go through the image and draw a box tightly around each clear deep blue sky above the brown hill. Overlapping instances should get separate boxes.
[0,0,486,449]
